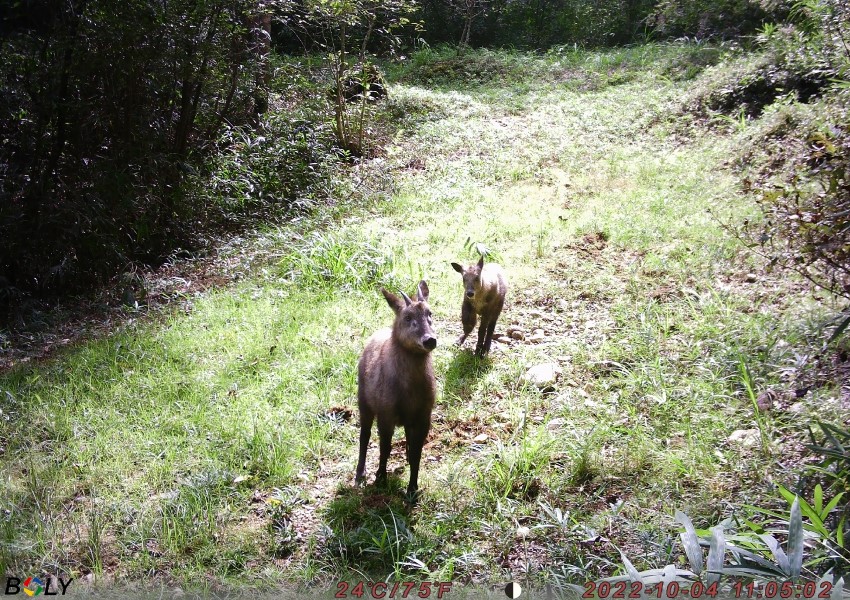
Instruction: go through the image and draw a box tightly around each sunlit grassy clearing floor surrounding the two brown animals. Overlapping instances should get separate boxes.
[0,46,850,595]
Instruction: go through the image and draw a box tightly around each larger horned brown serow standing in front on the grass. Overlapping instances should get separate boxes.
[355,281,437,499]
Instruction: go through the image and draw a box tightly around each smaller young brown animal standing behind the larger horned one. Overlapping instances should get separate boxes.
[452,256,508,356]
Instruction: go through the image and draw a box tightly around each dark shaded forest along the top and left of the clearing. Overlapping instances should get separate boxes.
[0,0,847,317]
